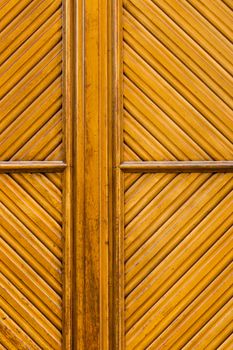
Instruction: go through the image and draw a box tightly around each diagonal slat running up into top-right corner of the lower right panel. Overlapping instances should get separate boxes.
[126,176,232,290]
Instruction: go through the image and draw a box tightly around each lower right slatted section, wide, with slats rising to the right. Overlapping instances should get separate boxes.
[124,173,233,350]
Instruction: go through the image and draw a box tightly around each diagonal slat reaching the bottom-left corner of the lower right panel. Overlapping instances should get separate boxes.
[126,226,232,348]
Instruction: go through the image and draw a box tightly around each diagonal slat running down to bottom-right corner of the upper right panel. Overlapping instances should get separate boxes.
[124,46,233,160]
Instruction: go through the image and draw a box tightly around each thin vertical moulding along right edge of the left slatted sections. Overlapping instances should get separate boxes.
[61,0,73,349]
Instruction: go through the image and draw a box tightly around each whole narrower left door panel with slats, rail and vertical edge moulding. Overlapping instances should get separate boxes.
[0,0,73,349]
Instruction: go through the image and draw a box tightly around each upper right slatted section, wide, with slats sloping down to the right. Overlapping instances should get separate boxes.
[123,0,233,160]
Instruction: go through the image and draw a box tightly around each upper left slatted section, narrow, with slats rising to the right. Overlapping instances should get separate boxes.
[0,0,63,160]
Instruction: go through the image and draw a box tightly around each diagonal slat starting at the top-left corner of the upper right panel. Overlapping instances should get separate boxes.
[124,0,232,99]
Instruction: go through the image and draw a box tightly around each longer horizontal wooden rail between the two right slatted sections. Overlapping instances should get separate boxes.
[120,161,233,173]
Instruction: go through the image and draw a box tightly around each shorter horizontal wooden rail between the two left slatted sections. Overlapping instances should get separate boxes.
[0,161,66,173]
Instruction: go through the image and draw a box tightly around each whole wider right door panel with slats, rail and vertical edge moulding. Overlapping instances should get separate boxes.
[112,0,233,350]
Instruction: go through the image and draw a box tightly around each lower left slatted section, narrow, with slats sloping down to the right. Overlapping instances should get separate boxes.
[0,173,63,349]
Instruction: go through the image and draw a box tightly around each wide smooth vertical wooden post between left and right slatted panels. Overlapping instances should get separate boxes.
[74,0,112,350]
